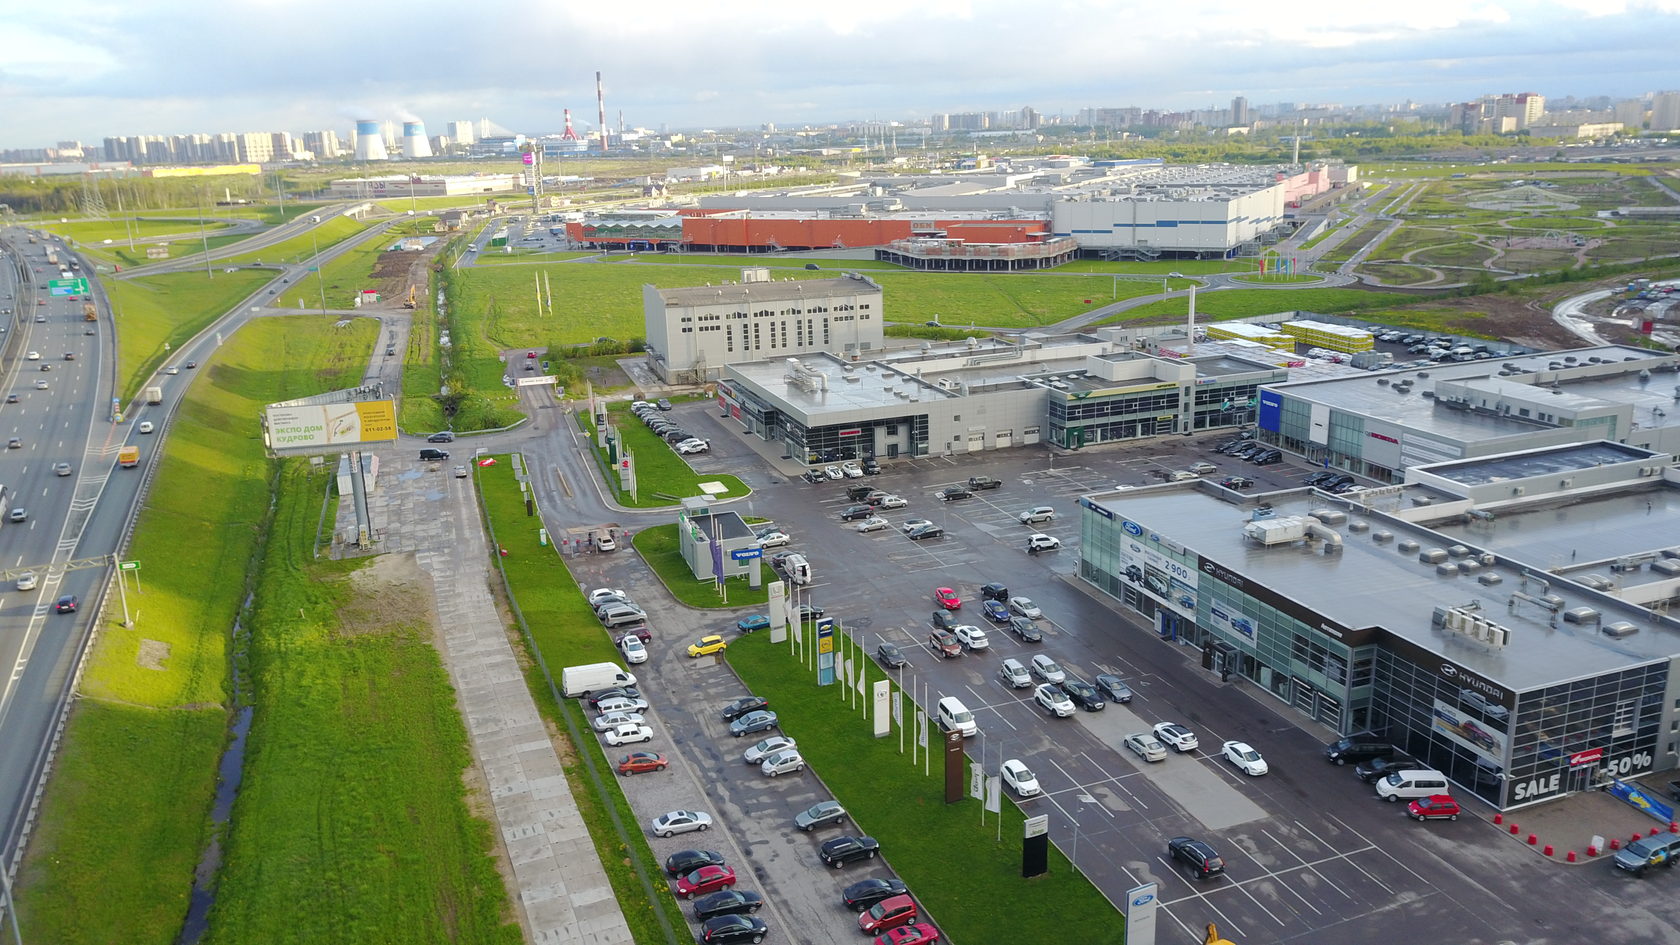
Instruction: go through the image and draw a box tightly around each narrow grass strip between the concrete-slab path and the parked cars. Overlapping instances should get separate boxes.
[474,456,687,945]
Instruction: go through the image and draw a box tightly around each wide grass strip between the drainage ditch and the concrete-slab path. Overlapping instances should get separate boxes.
[210,461,521,945]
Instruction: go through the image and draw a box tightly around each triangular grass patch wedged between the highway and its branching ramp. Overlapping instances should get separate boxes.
[102,269,274,413]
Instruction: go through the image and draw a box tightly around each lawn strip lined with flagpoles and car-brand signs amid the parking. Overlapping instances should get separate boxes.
[719,632,1124,945]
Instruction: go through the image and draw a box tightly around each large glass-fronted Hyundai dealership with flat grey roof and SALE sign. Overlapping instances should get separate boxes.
[1079,441,1680,809]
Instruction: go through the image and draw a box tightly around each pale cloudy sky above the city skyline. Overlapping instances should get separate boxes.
[0,0,1680,148]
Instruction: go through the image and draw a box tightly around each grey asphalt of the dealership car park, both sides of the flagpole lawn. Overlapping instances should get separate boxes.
[544,404,1670,943]
